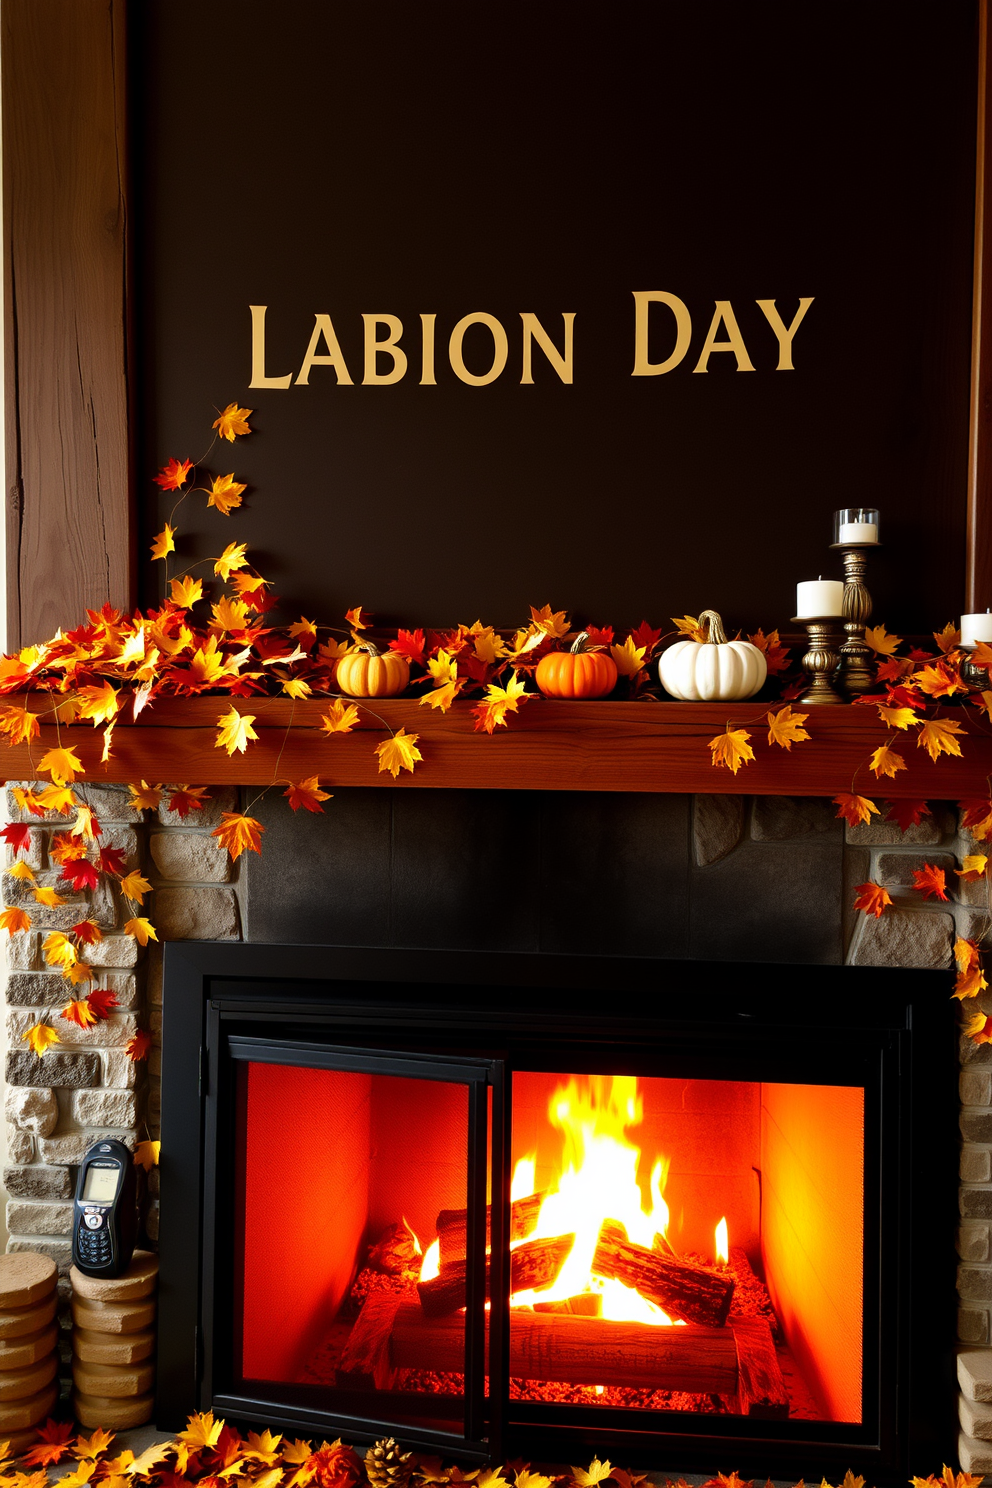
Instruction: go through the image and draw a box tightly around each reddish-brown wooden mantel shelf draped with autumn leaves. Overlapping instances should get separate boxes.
[0,698,992,801]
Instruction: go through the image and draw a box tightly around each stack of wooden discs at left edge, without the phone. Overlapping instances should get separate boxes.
[0,1250,58,1455]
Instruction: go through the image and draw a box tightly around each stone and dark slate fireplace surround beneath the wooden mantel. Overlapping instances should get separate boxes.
[4,786,992,1472]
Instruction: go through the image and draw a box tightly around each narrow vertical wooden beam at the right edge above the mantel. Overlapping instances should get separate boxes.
[965,0,992,612]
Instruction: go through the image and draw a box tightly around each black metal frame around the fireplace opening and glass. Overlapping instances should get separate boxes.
[156,942,956,1484]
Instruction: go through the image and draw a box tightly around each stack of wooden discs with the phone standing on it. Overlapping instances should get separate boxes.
[70,1250,159,1431]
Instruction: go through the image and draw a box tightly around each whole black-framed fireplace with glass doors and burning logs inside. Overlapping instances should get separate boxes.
[159,943,956,1482]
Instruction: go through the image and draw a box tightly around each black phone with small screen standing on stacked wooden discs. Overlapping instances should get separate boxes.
[73,1138,138,1277]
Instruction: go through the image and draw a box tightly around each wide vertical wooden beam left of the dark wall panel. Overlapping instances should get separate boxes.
[0,0,134,647]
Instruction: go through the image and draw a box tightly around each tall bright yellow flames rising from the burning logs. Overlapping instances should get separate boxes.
[510,1074,684,1324]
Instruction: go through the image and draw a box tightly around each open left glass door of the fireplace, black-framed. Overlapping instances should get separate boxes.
[214,1037,491,1446]
